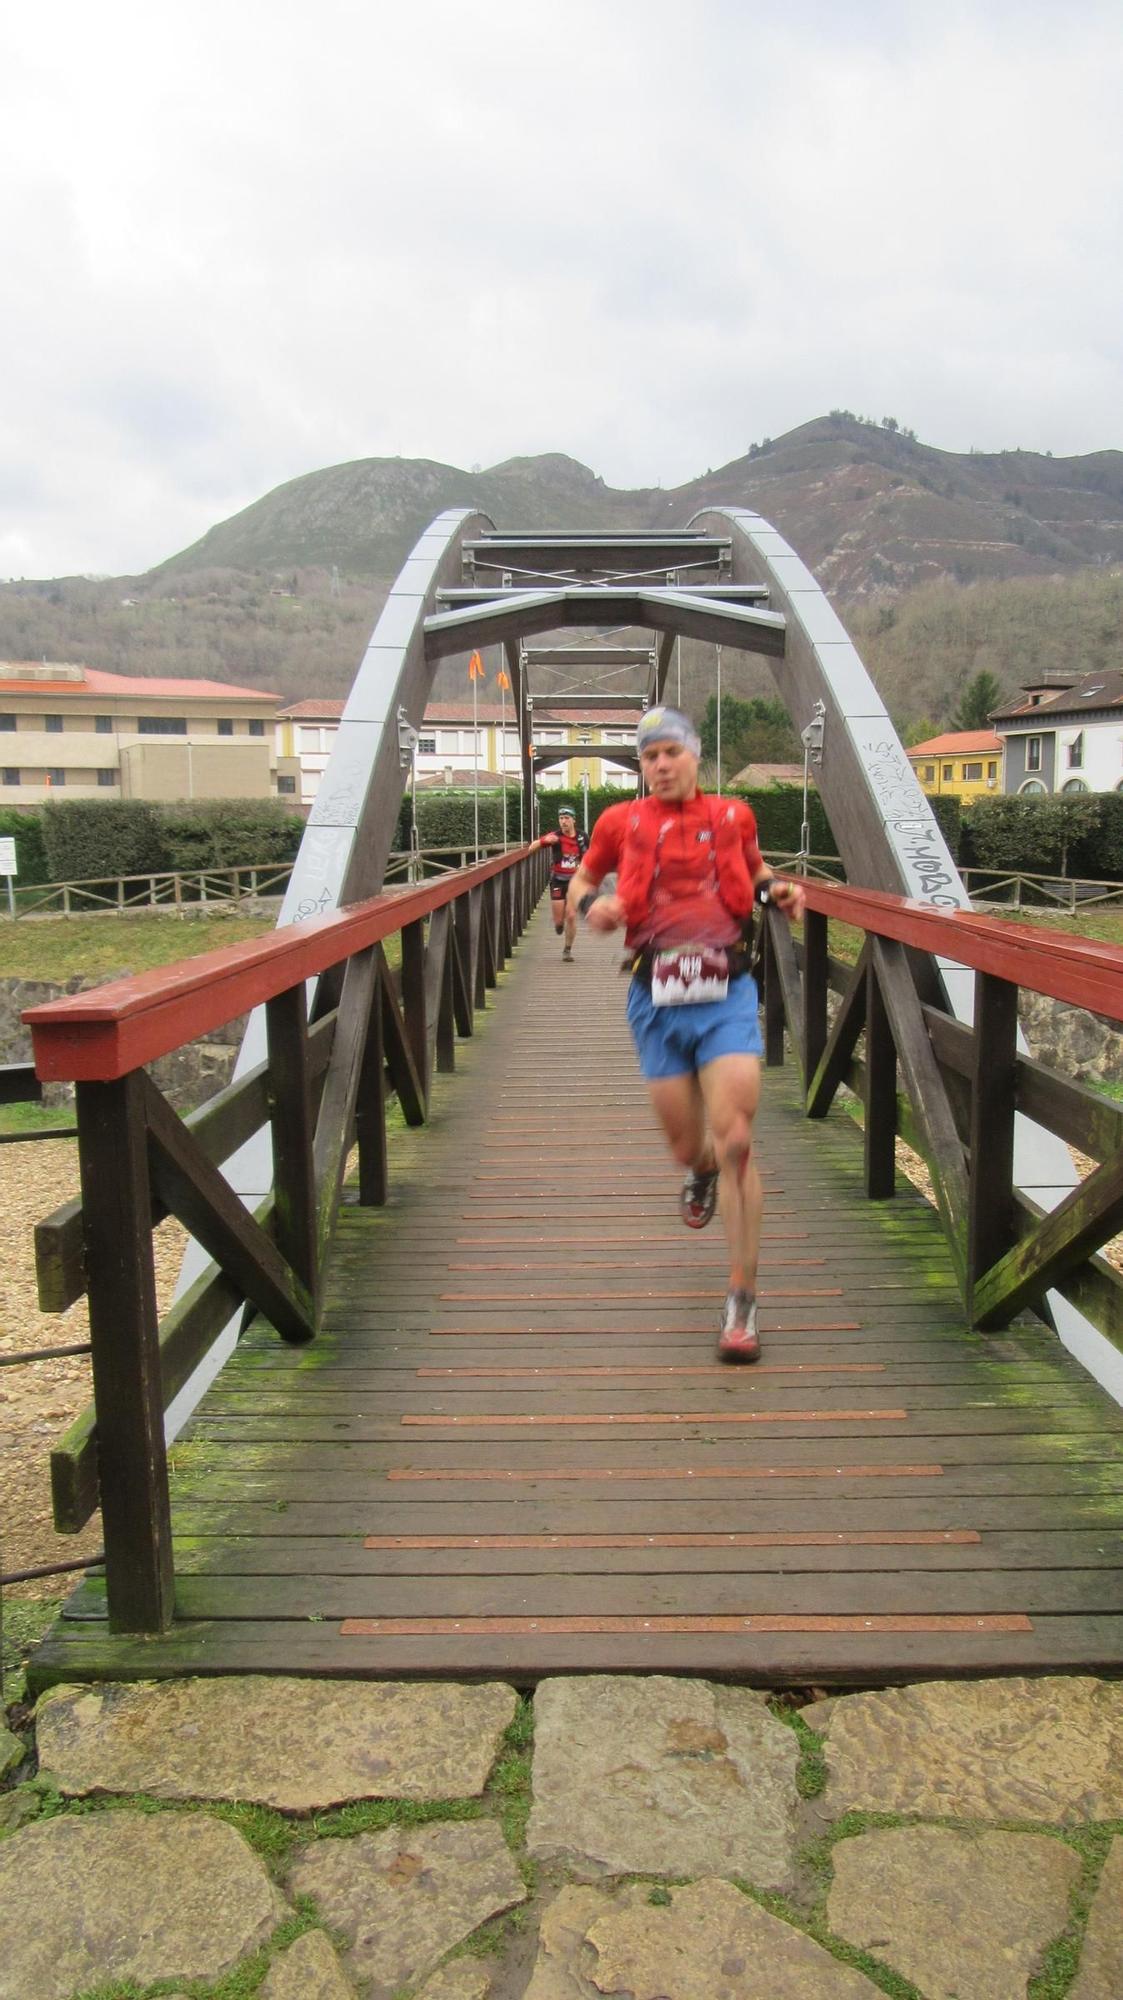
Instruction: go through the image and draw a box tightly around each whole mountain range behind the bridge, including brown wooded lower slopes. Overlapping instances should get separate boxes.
[0,410,1123,724]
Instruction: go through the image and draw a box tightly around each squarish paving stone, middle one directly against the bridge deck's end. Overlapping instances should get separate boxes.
[528,1674,799,1888]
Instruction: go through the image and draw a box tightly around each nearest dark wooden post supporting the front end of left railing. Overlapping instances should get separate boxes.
[76,1070,176,1632]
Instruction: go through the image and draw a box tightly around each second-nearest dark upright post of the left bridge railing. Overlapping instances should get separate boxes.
[266,984,320,1318]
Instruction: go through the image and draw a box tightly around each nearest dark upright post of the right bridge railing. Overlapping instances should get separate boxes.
[967,972,1017,1306]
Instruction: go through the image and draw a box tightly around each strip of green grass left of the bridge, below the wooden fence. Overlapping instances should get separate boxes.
[4,914,274,980]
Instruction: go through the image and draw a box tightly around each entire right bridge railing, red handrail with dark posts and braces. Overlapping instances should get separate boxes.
[763,880,1123,1348]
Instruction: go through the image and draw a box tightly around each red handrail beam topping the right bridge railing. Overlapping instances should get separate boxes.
[803,882,1123,1020]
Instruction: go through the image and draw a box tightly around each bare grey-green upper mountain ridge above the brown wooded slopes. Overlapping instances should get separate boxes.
[152,412,1123,604]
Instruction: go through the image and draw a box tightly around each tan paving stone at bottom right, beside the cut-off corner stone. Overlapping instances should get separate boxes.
[827,1826,1081,2000]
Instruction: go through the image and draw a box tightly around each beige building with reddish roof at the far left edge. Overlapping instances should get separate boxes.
[0,660,283,806]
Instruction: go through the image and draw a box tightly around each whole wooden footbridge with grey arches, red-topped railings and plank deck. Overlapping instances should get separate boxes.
[17,516,1123,1684]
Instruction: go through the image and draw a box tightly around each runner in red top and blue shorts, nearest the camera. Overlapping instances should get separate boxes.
[567,708,803,1362]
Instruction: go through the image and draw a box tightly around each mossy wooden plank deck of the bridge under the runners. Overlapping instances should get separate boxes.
[36,910,1123,1686]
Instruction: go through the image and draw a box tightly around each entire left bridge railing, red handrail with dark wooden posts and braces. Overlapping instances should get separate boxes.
[24,848,550,1632]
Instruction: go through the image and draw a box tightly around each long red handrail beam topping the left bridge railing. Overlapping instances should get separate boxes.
[22,848,534,1082]
